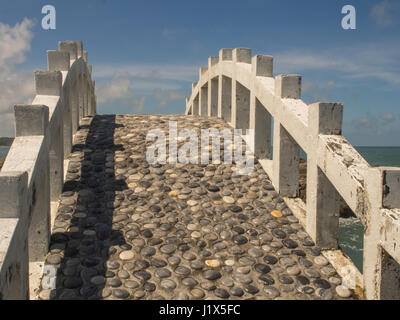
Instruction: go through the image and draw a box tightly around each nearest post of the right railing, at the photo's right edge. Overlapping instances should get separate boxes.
[363,167,400,300]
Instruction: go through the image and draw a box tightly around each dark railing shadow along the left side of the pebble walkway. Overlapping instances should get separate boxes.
[48,115,126,299]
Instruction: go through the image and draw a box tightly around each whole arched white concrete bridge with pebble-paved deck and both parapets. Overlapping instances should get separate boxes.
[0,41,400,299]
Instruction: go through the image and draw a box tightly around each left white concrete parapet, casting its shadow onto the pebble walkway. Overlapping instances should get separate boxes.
[0,41,96,299]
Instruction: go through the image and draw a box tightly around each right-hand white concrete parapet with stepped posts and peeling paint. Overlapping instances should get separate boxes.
[186,48,400,299]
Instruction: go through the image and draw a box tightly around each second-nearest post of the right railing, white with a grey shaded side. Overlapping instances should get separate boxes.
[306,102,343,249]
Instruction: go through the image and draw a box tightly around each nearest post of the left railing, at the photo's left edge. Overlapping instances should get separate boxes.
[0,172,29,300]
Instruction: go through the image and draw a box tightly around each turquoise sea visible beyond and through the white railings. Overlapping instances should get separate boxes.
[0,146,400,271]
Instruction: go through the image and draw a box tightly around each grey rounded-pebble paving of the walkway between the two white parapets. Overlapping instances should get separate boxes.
[39,115,351,300]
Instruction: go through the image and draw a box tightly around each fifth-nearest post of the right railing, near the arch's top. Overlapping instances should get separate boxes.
[231,48,251,129]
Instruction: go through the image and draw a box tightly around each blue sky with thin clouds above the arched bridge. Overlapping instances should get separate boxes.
[0,0,400,146]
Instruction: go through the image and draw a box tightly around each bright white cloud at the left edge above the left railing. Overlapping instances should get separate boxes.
[0,18,34,136]
